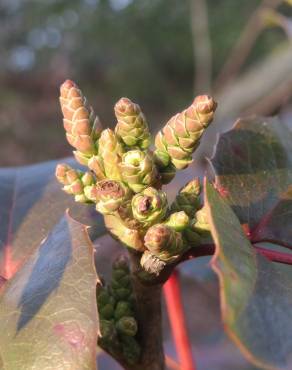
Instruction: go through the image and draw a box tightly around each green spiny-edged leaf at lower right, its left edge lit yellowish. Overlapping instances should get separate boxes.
[205,184,292,370]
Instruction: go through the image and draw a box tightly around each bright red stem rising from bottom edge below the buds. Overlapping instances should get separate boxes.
[164,270,196,370]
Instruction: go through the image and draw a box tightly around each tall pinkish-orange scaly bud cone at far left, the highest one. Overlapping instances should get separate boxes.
[60,80,101,161]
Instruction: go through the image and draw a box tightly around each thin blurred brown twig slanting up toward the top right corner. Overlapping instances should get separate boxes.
[214,0,283,91]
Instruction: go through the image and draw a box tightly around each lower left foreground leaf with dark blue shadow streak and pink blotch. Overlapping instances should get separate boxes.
[0,215,98,370]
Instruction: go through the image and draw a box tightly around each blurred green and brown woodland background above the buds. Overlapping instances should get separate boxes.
[0,0,292,166]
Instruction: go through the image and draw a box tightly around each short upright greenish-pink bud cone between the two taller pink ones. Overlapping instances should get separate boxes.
[115,98,150,149]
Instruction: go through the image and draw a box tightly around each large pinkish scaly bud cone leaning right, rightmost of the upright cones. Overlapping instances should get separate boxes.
[155,95,217,169]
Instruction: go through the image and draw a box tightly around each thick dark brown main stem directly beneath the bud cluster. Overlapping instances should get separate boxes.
[129,252,165,370]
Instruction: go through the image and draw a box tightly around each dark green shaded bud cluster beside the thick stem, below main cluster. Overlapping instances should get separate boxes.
[97,257,141,364]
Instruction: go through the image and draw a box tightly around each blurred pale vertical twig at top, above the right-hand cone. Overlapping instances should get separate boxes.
[190,0,212,93]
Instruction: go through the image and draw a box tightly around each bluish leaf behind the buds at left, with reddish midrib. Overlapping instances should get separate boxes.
[0,159,105,279]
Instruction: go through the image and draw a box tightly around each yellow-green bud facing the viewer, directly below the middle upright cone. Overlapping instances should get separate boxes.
[120,150,157,193]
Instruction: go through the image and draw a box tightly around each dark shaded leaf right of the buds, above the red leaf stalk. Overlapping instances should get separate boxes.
[211,118,292,244]
